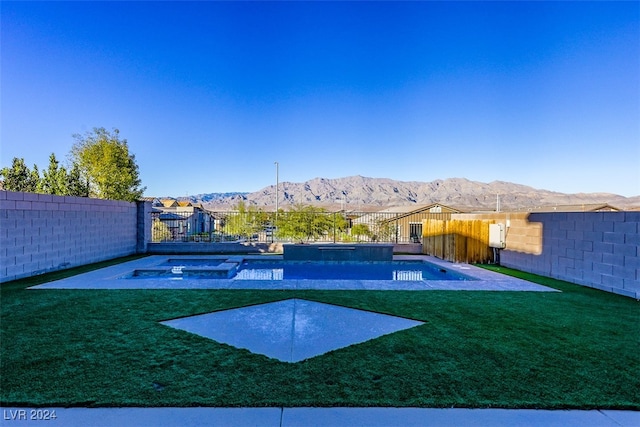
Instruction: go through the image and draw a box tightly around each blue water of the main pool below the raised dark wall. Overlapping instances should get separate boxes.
[234,261,473,281]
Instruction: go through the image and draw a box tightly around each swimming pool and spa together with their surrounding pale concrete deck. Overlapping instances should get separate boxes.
[29,254,557,292]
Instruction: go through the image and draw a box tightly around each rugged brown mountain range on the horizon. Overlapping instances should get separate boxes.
[170,176,640,210]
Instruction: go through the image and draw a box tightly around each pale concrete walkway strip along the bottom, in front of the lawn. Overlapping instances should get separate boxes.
[0,408,640,427]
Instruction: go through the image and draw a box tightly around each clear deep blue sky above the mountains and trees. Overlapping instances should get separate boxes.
[0,1,640,196]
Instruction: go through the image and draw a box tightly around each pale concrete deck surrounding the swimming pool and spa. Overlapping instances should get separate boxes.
[30,255,559,292]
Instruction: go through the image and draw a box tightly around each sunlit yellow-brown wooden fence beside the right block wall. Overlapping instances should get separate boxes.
[422,219,495,263]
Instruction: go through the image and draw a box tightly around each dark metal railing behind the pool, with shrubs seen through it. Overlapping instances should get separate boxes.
[151,207,422,243]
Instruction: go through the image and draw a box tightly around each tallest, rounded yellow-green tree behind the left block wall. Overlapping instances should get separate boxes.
[71,128,145,201]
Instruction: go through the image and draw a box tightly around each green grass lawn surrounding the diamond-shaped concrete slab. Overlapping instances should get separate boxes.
[0,258,640,410]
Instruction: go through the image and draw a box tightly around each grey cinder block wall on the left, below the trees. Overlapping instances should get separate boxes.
[0,191,138,282]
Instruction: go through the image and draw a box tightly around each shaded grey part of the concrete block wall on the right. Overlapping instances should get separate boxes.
[500,212,640,299]
